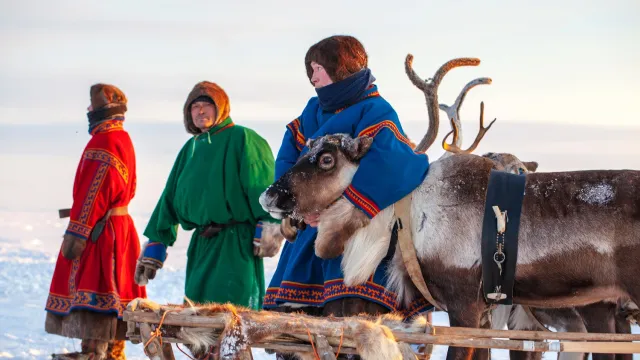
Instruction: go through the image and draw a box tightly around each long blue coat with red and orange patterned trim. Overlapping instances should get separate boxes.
[264,85,431,316]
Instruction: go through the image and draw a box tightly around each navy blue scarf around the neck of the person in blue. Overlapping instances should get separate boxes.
[316,68,376,112]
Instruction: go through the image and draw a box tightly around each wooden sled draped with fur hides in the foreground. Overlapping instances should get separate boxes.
[124,299,640,360]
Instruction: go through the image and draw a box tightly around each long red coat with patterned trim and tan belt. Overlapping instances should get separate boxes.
[46,120,146,318]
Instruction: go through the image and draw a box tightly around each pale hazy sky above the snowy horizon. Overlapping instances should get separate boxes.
[0,0,640,127]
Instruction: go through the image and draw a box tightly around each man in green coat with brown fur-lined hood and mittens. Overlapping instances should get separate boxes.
[134,81,284,310]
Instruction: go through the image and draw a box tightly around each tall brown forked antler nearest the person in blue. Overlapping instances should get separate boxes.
[404,54,480,153]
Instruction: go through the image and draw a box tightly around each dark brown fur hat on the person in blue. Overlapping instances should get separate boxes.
[304,35,368,82]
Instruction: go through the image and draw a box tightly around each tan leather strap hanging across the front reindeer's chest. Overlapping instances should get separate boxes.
[394,194,446,311]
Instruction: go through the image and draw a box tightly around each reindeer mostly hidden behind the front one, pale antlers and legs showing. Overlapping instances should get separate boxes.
[436,72,638,360]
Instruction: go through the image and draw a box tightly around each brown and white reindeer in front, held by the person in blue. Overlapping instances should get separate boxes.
[260,55,640,359]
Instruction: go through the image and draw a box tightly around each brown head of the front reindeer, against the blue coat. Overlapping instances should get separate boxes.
[260,134,373,224]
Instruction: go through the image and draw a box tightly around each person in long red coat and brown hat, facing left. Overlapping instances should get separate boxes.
[45,84,146,360]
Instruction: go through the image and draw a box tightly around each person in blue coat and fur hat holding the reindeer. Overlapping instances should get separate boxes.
[264,36,431,358]
